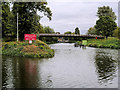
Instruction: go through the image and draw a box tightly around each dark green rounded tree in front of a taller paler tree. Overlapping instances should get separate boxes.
[95,16,117,38]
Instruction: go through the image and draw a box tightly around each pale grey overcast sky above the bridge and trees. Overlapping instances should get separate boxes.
[40,0,118,34]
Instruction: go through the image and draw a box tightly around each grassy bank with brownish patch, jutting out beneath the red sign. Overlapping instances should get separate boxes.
[2,40,54,58]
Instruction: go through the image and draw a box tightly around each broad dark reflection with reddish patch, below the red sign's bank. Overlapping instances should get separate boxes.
[2,57,42,88]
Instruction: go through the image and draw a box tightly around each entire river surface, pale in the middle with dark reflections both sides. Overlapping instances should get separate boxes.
[2,43,118,88]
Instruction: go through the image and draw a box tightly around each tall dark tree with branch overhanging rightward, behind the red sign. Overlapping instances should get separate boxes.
[12,2,52,40]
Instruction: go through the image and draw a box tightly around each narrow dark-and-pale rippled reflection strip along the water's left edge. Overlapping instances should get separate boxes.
[2,56,14,89]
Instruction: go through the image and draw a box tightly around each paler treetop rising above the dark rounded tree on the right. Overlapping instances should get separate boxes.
[97,6,116,21]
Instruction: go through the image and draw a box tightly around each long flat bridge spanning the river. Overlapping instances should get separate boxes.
[39,34,104,39]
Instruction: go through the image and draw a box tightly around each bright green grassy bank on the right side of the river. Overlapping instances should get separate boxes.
[87,38,120,49]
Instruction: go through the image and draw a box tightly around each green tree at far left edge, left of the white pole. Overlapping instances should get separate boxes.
[2,2,15,39]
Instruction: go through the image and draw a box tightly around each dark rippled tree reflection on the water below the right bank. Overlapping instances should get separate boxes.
[95,50,117,83]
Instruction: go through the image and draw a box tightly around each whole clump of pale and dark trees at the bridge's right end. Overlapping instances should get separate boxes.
[87,6,118,38]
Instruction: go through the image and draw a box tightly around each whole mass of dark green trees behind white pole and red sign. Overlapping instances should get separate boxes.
[2,2,52,40]
